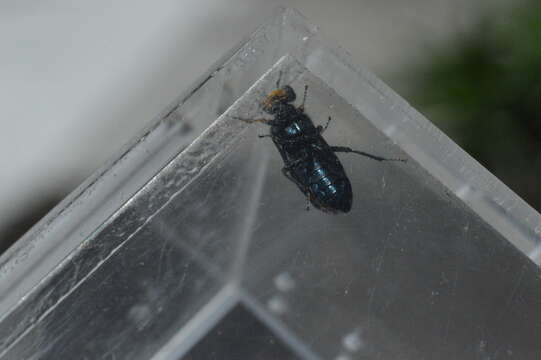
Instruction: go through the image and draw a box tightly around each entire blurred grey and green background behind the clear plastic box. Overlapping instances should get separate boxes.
[0,0,541,252]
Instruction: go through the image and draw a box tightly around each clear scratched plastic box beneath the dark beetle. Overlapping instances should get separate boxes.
[0,9,541,360]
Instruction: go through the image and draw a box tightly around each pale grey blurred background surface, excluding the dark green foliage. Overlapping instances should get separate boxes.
[0,0,507,242]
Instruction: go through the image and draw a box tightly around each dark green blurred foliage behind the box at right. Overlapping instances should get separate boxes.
[405,1,541,211]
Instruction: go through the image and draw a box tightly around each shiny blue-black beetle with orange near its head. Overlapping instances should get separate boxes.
[235,73,405,213]
